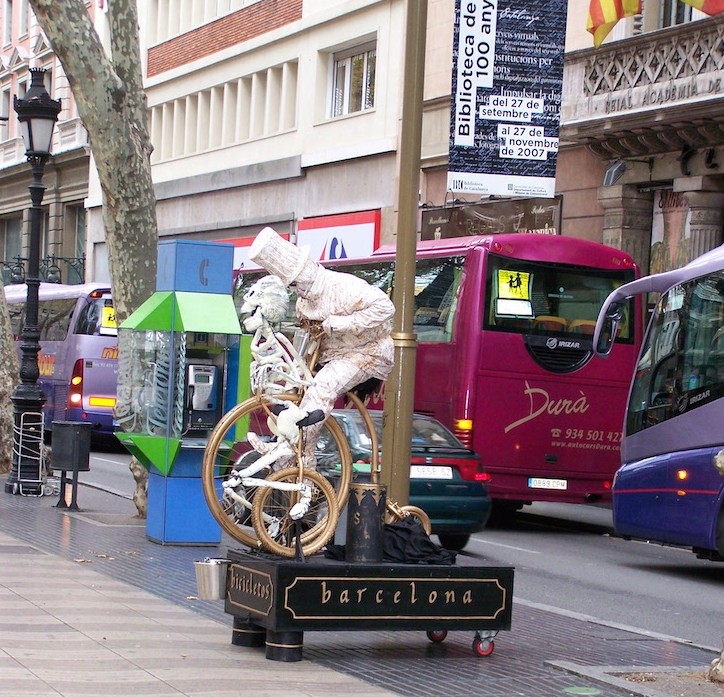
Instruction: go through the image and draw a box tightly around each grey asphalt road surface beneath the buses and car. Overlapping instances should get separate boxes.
[86,449,724,651]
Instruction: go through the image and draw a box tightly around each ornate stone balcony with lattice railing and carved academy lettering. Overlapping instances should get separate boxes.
[561,15,724,157]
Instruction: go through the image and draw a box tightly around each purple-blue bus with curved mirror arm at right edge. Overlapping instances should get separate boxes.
[594,246,724,561]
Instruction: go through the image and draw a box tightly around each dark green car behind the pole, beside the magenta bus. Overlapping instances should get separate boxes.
[317,409,491,551]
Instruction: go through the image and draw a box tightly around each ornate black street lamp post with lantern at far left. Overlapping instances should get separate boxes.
[5,68,60,495]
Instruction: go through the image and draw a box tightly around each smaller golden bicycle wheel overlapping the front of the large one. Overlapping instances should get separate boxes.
[251,467,339,558]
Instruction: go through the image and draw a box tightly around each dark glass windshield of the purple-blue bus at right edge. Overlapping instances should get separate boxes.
[626,271,724,435]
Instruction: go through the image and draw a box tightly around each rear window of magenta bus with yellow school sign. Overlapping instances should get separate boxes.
[485,253,633,343]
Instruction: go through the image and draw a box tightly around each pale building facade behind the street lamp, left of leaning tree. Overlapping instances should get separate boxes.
[0,0,93,283]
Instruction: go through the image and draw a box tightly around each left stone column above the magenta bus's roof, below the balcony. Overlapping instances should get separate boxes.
[598,184,654,274]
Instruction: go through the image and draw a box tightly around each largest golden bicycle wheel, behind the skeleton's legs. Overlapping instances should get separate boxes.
[201,394,352,549]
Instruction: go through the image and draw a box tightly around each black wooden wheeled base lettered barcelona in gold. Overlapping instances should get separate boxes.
[224,550,514,661]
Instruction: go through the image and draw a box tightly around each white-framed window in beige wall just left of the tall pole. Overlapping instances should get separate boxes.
[331,43,377,117]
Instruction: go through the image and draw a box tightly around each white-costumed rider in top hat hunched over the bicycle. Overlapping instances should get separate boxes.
[249,227,395,467]
